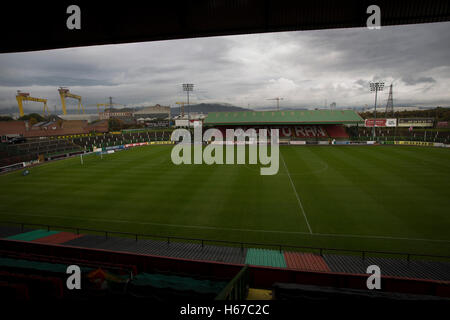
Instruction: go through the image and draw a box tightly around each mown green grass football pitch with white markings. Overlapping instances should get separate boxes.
[0,146,450,255]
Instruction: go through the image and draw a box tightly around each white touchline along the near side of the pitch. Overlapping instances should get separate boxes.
[0,212,450,243]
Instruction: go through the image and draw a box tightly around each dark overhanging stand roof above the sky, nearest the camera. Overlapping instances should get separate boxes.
[0,0,450,53]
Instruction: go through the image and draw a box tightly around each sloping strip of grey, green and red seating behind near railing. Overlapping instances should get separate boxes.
[0,226,450,281]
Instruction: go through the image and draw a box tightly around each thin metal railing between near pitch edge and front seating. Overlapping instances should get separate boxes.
[0,220,450,261]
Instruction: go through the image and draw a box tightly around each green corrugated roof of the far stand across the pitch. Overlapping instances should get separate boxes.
[204,110,364,125]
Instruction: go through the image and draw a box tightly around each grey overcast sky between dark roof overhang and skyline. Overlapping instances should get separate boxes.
[0,22,450,112]
